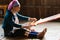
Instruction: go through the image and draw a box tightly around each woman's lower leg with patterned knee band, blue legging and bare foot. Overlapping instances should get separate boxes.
[25,28,47,39]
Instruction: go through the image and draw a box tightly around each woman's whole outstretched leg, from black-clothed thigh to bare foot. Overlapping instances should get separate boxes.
[14,28,47,39]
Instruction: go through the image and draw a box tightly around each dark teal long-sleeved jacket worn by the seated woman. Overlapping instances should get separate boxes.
[2,10,29,32]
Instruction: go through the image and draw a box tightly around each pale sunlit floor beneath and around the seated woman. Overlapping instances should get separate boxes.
[0,22,60,40]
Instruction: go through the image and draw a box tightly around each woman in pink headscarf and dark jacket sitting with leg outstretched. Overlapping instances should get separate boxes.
[2,0,47,38]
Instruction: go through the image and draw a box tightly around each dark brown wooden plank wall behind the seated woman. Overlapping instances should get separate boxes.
[0,0,60,19]
